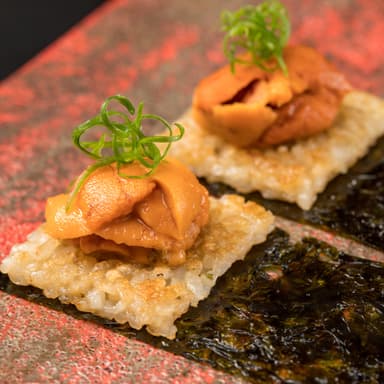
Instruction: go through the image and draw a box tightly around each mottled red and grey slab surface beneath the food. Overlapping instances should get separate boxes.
[0,0,384,383]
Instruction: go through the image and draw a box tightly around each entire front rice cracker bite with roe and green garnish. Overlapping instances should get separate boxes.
[0,95,274,338]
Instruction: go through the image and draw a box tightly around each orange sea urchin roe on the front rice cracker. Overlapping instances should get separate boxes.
[45,159,209,264]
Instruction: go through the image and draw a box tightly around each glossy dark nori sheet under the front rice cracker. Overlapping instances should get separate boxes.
[0,230,384,383]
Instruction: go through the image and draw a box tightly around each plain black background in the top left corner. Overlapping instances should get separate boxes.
[0,0,104,80]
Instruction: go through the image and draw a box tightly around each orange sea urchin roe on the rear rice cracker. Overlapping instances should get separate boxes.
[193,46,351,147]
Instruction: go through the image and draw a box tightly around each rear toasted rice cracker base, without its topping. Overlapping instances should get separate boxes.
[169,91,384,209]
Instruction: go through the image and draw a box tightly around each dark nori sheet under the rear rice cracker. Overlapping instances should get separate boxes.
[206,137,384,250]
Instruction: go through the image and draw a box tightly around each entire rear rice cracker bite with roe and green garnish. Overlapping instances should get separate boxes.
[171,0,384,209]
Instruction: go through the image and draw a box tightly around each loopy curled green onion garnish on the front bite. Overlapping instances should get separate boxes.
[66,95,184,210]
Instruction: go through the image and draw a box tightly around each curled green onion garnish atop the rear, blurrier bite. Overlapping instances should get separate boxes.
[221,0,291,74]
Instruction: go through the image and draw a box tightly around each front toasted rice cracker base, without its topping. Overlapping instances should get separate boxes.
[0,195,274,339]
